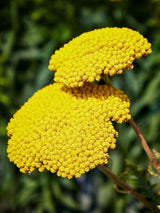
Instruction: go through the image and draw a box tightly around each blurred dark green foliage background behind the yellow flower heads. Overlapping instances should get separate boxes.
[0,0,160,213]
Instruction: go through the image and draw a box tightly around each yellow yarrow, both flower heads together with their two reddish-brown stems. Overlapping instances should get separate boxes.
[7,27,160,212]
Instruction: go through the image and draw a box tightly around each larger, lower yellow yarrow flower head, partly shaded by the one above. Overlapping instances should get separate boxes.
[7,83,130,178]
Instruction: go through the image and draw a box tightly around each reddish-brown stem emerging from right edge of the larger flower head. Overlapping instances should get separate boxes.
[129,118,160,174]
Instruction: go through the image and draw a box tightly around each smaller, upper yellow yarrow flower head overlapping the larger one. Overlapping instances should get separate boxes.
[49,27,151,87]
